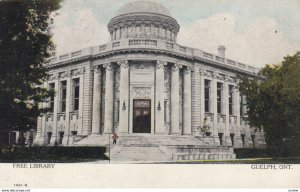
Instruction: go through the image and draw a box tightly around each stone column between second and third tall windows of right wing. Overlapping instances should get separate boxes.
[222,76,232,145]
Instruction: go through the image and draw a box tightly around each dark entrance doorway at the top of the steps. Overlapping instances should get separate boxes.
[132,99,151,133]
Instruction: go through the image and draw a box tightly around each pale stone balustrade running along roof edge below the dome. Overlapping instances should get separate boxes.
[49,39,260,74]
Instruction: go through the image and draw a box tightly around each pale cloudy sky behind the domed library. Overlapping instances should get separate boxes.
[52,0,300,67]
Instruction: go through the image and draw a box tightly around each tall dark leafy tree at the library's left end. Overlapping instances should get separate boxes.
[0,0,60,135]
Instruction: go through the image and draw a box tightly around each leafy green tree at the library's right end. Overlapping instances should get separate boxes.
[239,52,300,156]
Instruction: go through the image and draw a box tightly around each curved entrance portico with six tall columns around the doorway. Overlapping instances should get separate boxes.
[91,60,192,135]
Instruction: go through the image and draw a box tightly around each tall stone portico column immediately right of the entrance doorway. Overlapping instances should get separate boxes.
[154,61,167,134]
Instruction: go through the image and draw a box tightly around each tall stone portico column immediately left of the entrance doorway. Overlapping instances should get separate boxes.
[118,61,129,134]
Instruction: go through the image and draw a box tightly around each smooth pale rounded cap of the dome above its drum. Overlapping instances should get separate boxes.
[115,1,172,17]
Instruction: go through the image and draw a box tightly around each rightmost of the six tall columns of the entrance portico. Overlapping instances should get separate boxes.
[183,67,192,135]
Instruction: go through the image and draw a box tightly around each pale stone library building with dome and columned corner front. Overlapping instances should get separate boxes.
[35,2,265,158]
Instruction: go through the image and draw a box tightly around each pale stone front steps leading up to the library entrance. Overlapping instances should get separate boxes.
[76,135,235,162]
